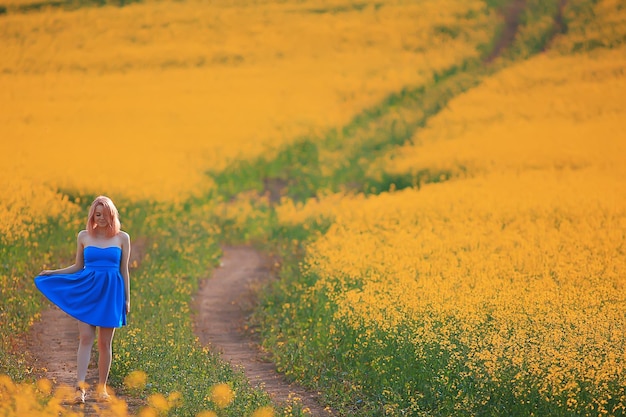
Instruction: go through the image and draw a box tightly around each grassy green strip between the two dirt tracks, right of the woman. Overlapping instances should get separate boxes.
[111,202,290,416]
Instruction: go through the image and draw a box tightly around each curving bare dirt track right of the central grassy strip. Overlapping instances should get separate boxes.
[195,247,332,417]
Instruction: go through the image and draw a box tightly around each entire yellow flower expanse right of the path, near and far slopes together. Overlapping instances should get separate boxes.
[278,5,626,415]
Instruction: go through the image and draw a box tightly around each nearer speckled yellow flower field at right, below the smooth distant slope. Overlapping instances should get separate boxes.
[294,171,626,406]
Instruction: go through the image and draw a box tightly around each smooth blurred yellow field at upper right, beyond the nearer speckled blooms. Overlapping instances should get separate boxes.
[372,47,626,181]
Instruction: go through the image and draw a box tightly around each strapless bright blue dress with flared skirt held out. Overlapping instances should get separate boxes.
[35,246,126,327]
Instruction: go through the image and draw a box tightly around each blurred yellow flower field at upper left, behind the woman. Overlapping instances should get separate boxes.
[0,0,495,244]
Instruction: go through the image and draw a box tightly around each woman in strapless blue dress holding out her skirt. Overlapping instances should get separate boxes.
[35,196,130,403]
